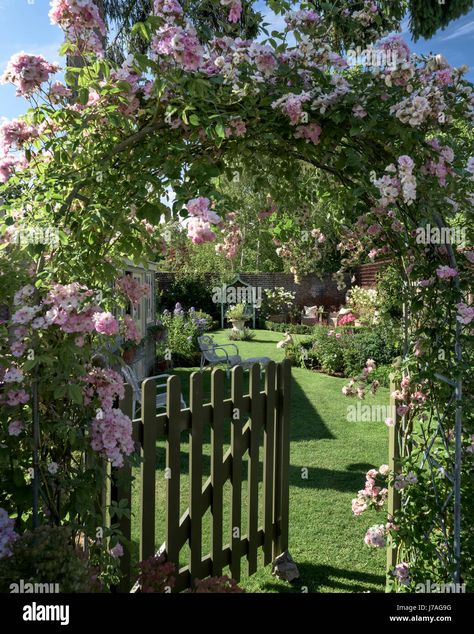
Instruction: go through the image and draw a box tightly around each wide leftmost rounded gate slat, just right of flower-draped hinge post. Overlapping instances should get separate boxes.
[140,379,157,560]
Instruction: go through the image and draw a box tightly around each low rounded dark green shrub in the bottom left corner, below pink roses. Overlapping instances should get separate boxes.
[0,526,94,593]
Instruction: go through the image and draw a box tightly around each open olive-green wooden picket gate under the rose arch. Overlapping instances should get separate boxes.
[111,360,291,592]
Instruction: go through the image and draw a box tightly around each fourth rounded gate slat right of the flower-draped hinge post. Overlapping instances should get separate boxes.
[211,368,224,577]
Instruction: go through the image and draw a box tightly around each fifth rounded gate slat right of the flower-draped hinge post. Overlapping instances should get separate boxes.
[230,366,243,581]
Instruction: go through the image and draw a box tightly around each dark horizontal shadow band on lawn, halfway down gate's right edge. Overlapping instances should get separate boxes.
[290,465,372,493]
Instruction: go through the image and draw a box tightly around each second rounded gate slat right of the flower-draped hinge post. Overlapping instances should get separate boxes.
[165,375,182,568]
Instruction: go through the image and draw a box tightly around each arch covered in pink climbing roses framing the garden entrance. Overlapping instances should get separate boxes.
[0,0,474,588]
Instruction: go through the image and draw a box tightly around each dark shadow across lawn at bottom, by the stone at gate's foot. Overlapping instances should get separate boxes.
[256,562,385,593]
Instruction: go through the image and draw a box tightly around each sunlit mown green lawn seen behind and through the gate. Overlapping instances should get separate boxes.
[134,330,388,592]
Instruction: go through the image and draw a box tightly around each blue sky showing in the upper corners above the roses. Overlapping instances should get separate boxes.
[0,0,474,120]
